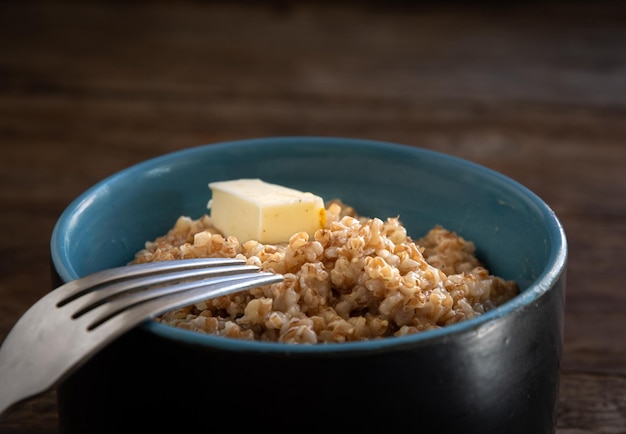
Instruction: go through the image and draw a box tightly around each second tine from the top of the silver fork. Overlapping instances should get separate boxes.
[67,263,259,318]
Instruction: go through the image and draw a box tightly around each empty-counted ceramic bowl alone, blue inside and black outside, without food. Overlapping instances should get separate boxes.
[51,137,567,434]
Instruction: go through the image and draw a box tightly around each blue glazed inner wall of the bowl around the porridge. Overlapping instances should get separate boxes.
[51,137,566,352]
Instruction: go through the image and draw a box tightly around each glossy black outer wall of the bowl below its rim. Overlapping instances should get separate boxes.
[57,274,565,434]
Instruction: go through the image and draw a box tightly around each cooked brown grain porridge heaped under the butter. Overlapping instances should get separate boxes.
[133,200,518,344]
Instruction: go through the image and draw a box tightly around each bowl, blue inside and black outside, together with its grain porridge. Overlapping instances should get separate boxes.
[51,137,567,434]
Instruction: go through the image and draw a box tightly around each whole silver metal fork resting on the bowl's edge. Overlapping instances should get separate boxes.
[0,258,283,416]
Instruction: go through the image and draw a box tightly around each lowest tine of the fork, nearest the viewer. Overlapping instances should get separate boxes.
[79,272,283,342]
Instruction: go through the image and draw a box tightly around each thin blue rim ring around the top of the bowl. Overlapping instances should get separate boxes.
[50,136,567,354]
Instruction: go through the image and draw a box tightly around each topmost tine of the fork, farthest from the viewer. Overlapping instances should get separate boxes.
[55,258,245,306]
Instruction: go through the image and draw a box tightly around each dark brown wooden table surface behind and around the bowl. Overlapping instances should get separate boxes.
[0,1,626,434]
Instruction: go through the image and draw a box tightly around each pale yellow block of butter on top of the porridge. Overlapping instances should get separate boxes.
[208,179,326,244]
